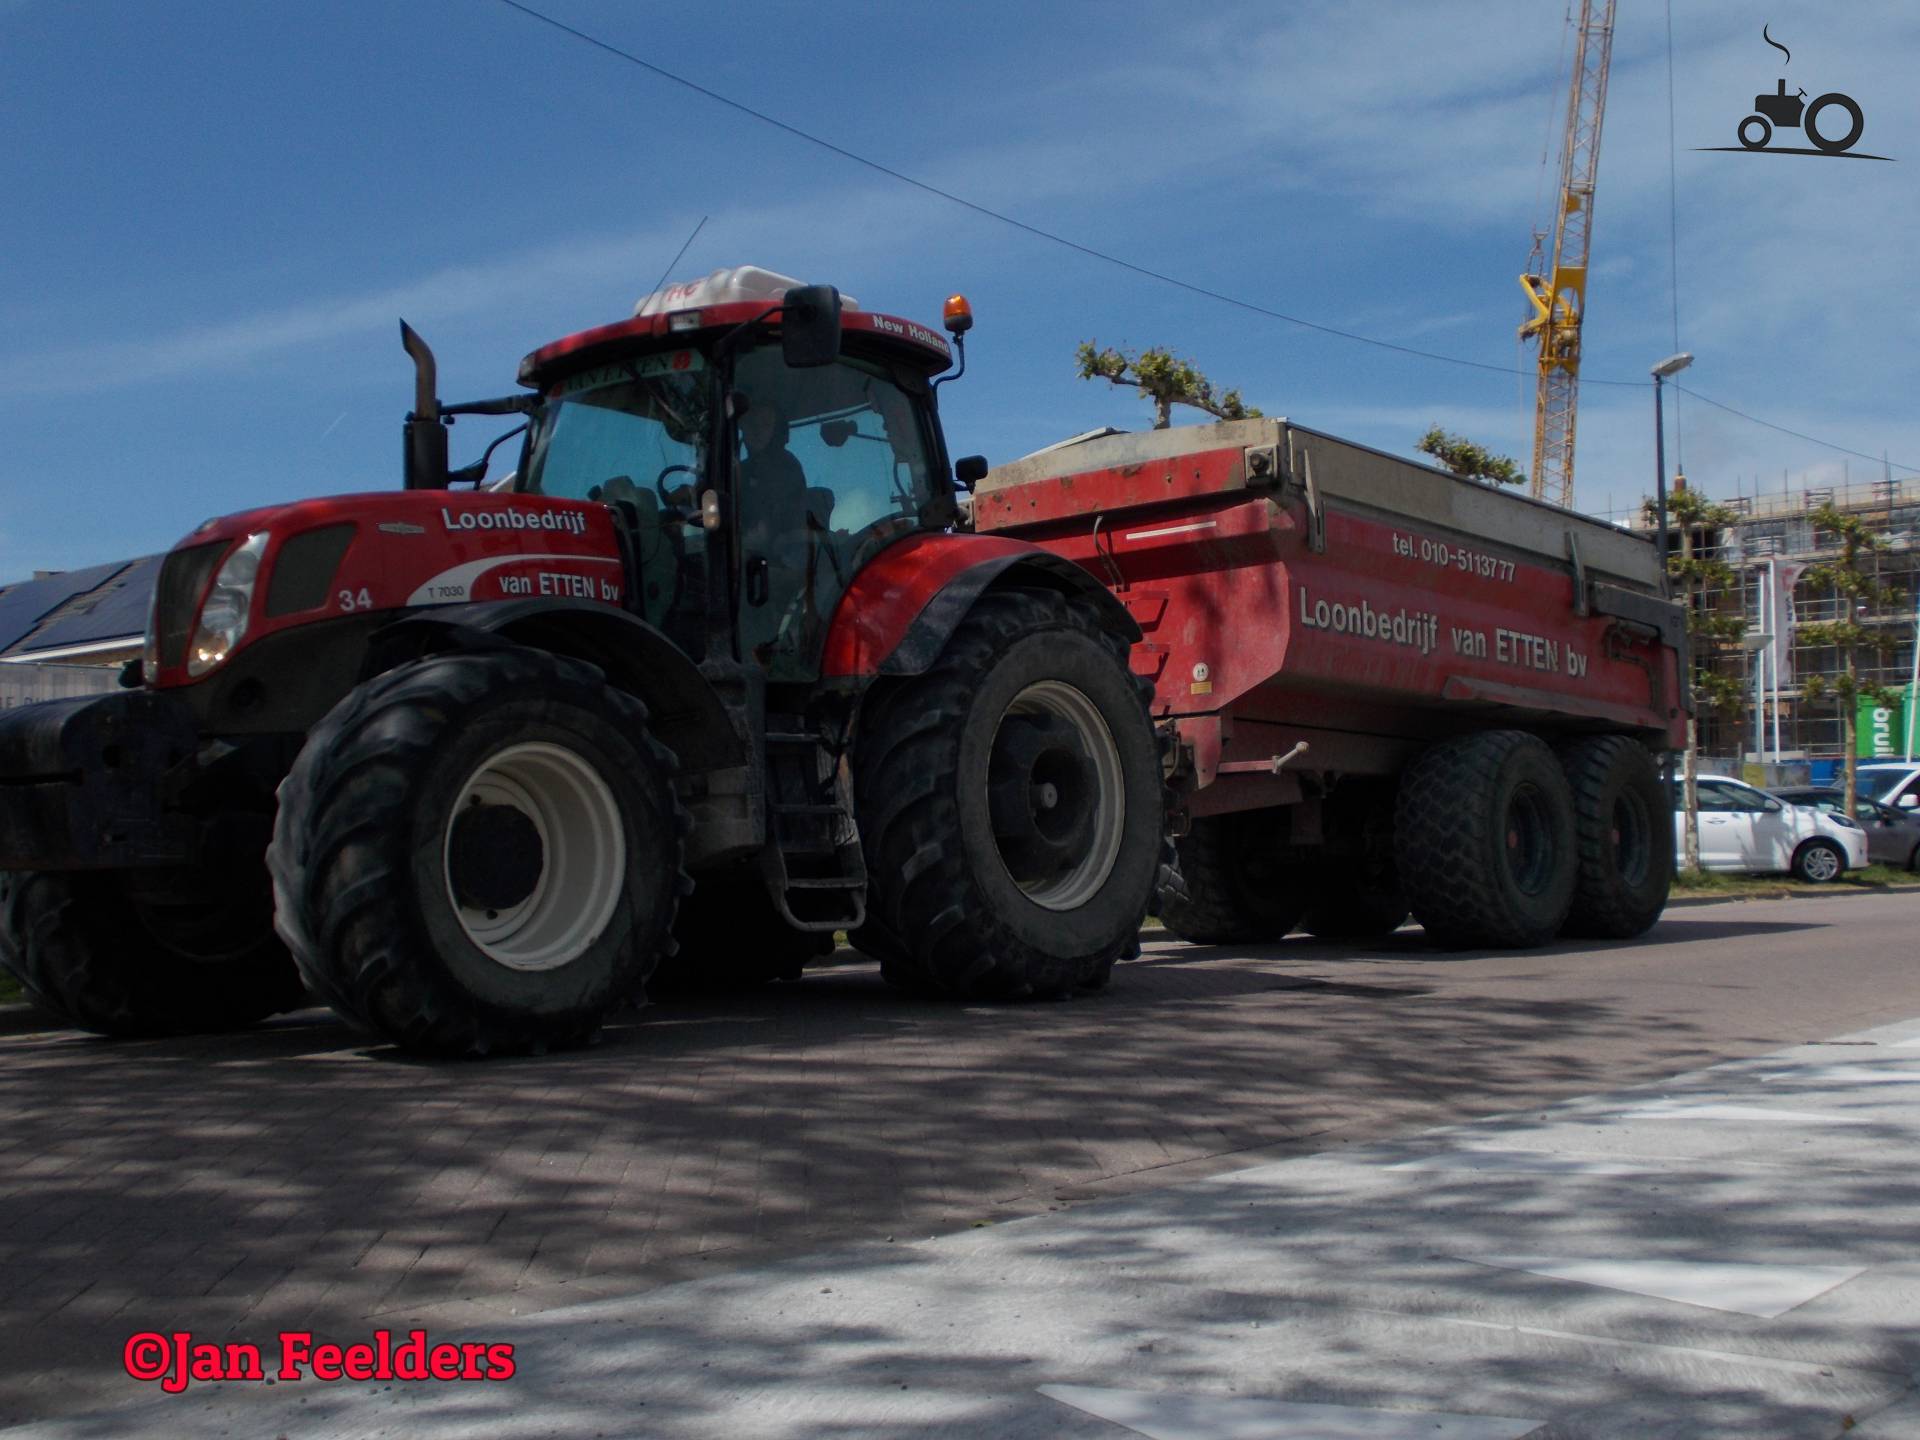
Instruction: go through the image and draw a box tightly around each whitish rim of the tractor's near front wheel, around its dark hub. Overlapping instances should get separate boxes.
[440,741,626,970]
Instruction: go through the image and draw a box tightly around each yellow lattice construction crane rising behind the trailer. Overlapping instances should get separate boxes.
[1521,0,1615,505]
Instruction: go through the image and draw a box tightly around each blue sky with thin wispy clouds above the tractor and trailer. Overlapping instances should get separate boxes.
[0,0,1920,582]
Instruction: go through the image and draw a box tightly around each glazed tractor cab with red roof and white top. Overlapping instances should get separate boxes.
[515,267,966,684]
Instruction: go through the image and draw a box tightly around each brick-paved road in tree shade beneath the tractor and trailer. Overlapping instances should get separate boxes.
[0,908,1910,1425]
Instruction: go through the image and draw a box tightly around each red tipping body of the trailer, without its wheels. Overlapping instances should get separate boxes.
[973,419,1690,814]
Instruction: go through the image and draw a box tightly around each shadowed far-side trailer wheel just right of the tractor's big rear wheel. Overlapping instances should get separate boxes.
[1160,810,1313,945]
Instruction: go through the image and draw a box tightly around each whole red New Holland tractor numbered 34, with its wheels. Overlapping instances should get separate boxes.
[0,269,1164,1054]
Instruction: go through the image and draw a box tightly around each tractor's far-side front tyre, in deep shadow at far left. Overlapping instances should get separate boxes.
[0,852,305,1037]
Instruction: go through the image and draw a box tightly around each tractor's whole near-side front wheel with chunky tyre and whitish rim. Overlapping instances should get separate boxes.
[269,647,691,1056]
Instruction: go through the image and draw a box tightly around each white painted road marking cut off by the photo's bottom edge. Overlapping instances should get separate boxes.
[1039,1384,1546,1440]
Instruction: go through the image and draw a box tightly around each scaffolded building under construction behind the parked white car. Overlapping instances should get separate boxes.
[1636,476,1920,766]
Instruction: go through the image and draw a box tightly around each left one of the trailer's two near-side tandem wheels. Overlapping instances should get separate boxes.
[1394,730,1574,947]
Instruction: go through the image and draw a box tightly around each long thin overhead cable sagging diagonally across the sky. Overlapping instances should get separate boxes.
[499,0,1916,470]
